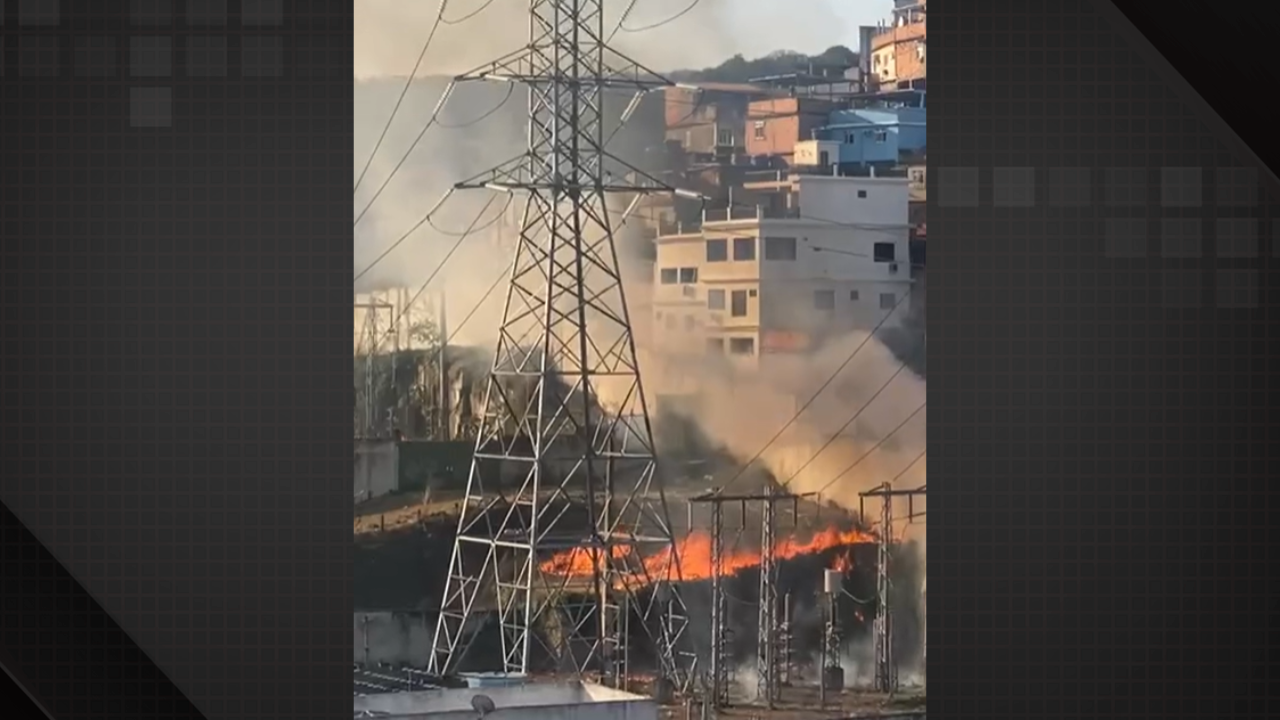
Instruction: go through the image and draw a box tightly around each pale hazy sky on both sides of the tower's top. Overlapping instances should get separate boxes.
[355,0,892,78]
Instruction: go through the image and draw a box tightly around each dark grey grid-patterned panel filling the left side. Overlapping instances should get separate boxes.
[0,0,353,720]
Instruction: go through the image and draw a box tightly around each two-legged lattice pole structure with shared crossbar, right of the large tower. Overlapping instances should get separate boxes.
[690,489,817,708]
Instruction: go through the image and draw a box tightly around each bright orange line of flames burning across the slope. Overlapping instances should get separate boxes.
[540,528,876,583]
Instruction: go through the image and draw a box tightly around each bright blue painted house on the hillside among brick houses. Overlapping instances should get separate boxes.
[814,108,928,165]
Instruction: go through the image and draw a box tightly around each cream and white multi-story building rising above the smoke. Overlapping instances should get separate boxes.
[652,174,911,366]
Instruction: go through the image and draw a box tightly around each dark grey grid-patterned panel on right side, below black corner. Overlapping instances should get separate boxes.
[929,0,1280,720]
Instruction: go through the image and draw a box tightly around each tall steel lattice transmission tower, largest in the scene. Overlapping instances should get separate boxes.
[429,0,692,688]
